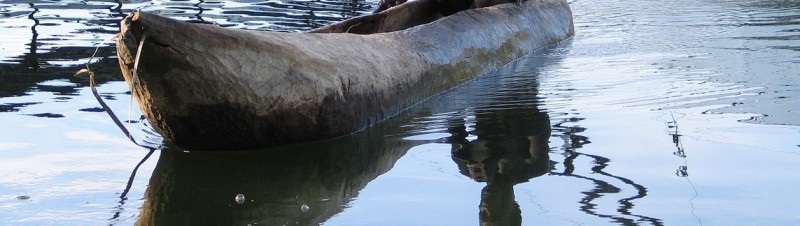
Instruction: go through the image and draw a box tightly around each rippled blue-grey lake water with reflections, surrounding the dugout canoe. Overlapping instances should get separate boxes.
[0,0,800,225]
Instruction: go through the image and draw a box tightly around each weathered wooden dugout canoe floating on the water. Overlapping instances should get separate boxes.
[117,0,574,150]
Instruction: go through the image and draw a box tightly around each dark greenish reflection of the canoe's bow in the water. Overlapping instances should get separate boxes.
[137,127,413,225]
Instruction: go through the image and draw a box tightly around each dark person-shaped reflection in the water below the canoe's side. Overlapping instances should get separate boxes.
[448,108,550,225]
